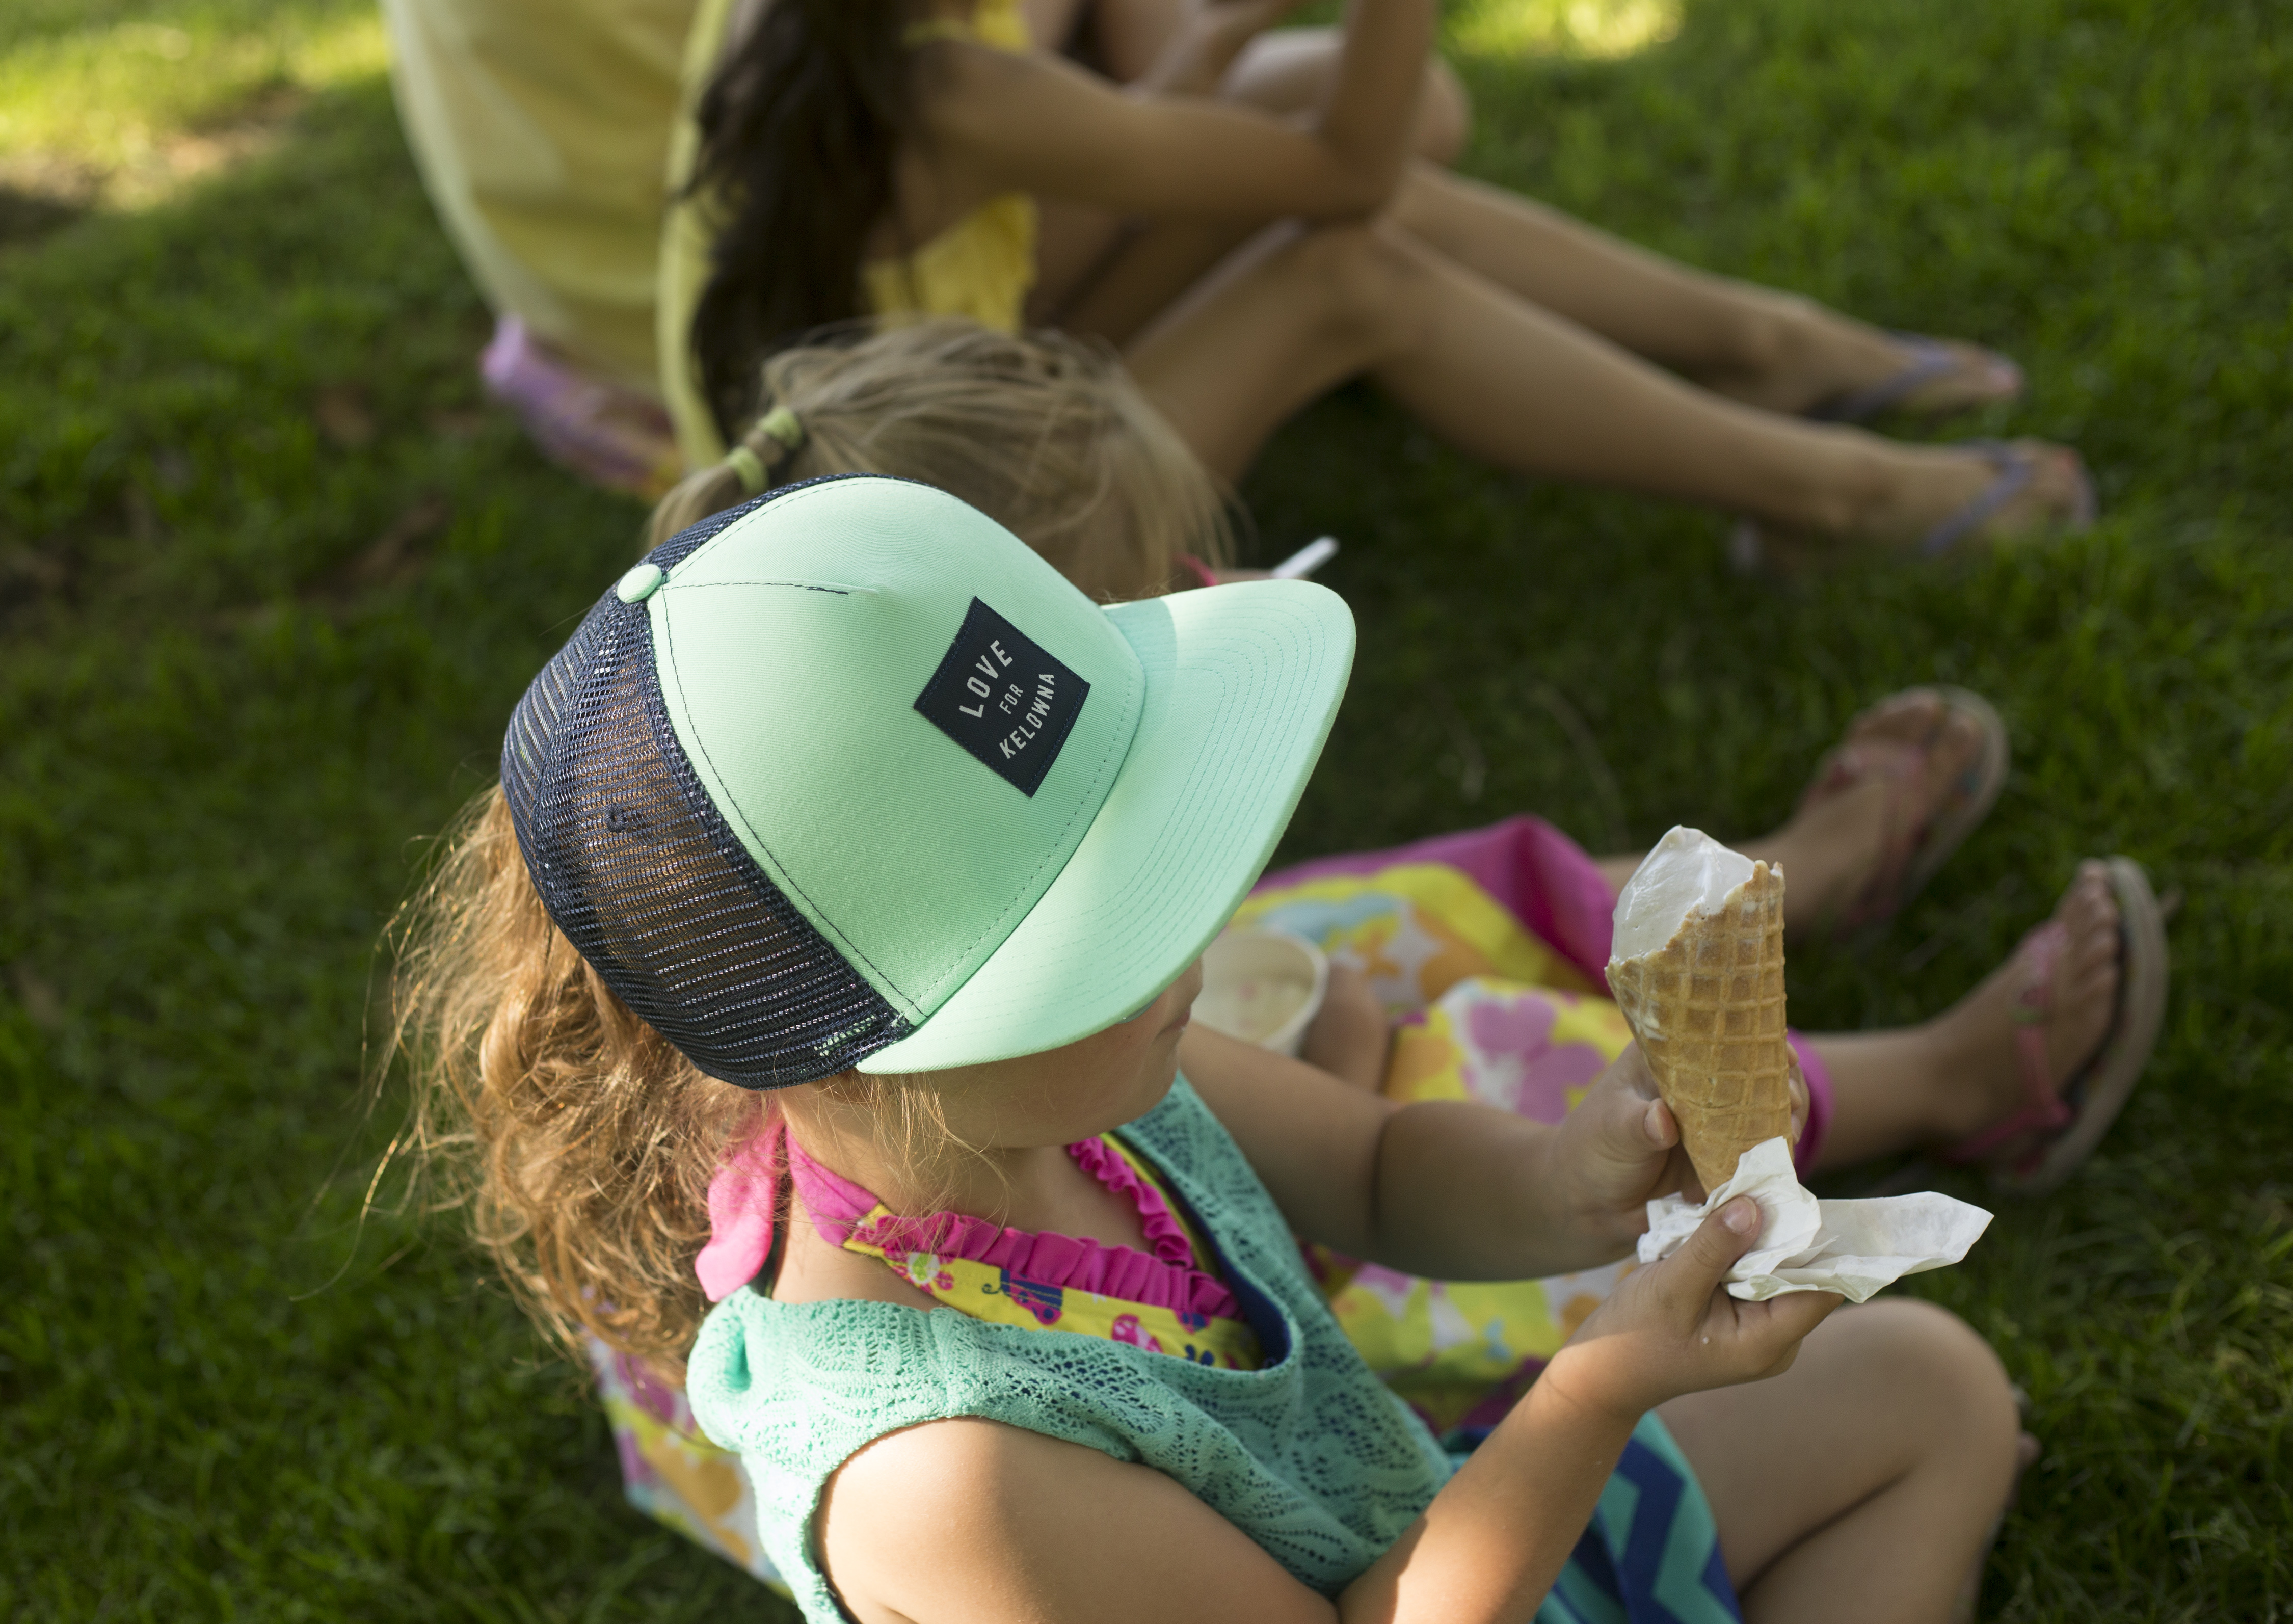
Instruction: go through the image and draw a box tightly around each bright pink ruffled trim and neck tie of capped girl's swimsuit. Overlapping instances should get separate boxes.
[695,1117,1241,1319]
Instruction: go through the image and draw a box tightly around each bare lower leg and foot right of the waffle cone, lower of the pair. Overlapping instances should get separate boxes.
[1809,863,2119,1172]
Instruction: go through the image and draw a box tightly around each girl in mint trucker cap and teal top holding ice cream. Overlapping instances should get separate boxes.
[415,463,2016,1624]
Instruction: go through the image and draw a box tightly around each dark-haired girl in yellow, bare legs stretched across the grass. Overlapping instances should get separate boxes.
[660,0,2091,564]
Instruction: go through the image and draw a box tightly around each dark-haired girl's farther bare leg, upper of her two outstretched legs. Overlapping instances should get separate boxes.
[1392,165,2022,411]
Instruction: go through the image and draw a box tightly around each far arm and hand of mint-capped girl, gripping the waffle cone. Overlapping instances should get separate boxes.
[1179,1025,1695,1280]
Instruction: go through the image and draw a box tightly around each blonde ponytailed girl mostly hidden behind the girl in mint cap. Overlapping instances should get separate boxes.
[601,321,2167,1449]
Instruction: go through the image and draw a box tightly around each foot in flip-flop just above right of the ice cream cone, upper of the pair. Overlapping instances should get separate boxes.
[1743,688,1984,931]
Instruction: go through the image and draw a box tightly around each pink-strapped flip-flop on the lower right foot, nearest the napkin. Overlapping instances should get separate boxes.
[1940,858,2169,1195]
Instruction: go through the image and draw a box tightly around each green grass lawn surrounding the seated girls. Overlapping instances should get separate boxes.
[0,0,2293,1621]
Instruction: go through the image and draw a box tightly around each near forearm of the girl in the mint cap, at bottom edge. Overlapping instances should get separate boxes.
[1337,1381,1640,1624]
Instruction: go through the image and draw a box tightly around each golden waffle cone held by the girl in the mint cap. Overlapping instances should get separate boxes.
[1608,863,1791,1190]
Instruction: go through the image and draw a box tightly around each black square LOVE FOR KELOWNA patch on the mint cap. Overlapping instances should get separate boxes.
[915,599,1091,796]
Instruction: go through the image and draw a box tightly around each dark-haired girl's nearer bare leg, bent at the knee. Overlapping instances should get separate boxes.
[1131,223,2077,544]
